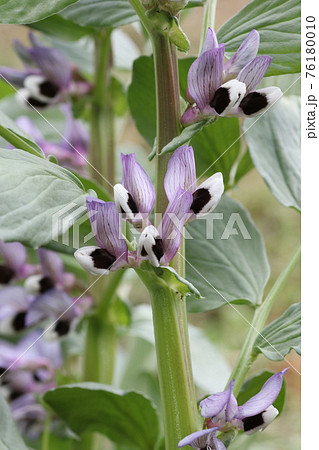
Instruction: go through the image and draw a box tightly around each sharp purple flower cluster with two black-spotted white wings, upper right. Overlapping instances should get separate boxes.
[182,28,282,125]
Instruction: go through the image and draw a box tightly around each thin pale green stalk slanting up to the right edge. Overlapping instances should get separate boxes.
[228,246,300,395]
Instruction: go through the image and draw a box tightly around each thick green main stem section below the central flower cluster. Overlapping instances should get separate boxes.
[137,269,199,450]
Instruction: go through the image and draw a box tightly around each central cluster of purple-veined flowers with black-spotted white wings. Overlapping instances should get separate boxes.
[75,146,224,275]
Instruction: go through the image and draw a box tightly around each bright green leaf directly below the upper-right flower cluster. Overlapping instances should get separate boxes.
[190,117,241,187]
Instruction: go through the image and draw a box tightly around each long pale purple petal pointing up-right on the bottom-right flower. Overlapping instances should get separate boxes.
[235,369,288,419]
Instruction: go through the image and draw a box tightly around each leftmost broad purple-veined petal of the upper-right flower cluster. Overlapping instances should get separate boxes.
[187,44,225,112]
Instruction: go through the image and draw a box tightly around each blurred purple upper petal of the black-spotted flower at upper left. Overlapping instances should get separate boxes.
[29,45,72,89]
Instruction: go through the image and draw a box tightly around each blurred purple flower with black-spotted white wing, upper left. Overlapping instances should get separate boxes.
[0,32,91,108]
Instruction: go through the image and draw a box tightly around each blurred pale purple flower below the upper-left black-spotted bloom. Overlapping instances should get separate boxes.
[16,104,89,175]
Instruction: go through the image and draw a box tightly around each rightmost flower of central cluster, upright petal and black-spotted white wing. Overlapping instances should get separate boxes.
[164,145,224,219]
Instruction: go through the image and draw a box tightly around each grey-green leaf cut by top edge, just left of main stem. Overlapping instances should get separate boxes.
[61,0,138,28]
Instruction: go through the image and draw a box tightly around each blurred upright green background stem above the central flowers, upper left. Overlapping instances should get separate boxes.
[90,28,115,193]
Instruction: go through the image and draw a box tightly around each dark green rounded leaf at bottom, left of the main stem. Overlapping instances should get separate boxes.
[44,383,158,450]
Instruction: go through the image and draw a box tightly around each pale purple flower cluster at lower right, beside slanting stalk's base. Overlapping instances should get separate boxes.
[200,369,288,434]
